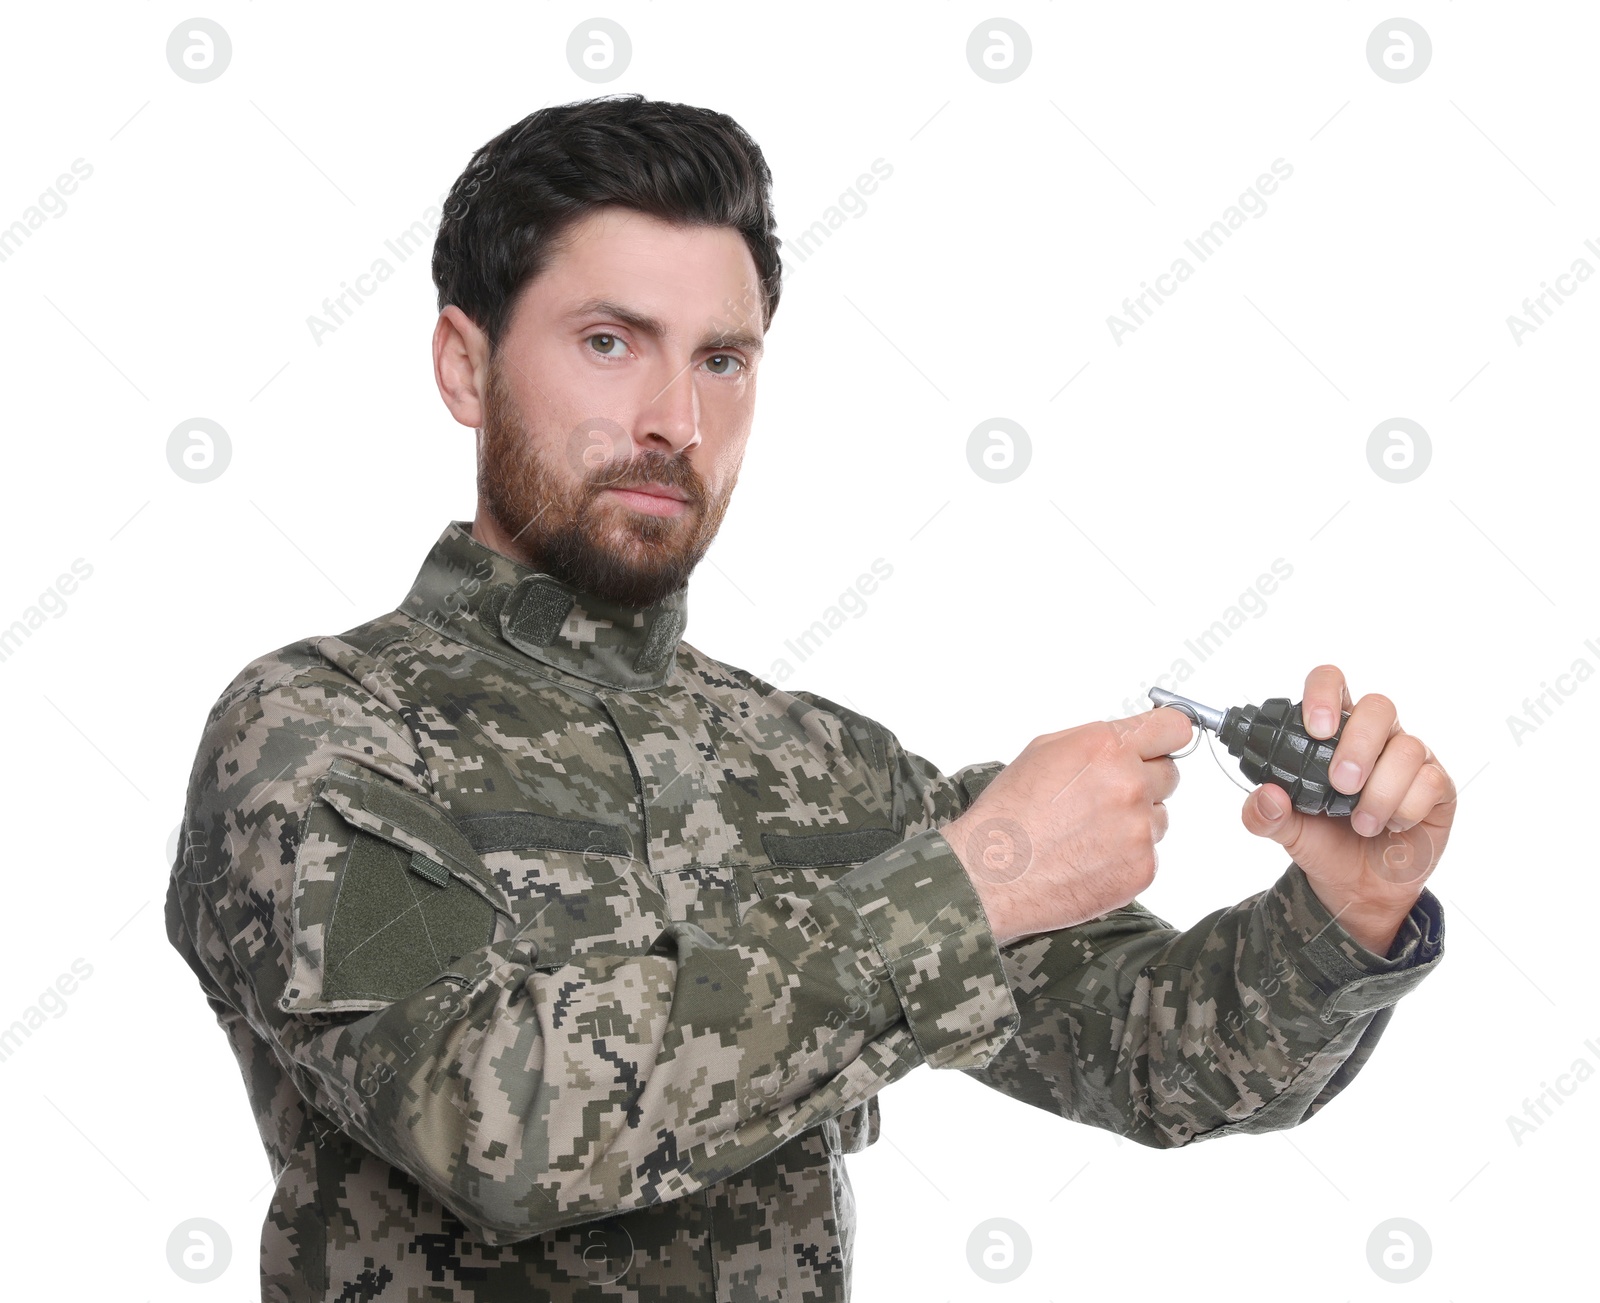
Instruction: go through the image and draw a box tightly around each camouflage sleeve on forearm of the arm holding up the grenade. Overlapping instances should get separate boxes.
[971,866,1442,1148]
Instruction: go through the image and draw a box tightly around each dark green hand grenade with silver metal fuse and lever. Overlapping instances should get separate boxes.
[1150,688,1362,816]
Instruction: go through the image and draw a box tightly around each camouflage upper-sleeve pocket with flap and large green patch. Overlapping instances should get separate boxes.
[278,760,510,1013]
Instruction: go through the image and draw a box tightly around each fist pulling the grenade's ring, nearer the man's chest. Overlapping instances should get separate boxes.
[939,706,1192,946]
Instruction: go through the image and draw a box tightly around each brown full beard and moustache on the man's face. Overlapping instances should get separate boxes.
[478,360,739,607]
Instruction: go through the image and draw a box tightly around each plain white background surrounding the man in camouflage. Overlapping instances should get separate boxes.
[0,3,1600,1303]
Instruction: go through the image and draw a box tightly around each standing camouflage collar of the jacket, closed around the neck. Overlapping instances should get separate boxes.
[400,520,688,690]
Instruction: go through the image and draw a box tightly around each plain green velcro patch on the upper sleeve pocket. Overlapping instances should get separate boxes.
[322,829,494,1000]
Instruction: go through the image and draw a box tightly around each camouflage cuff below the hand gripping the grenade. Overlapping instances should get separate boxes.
[1270,861,1445,1023]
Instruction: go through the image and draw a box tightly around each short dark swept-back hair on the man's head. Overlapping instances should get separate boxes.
[434,93,782,352]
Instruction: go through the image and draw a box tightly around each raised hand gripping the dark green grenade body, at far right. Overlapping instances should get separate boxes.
[1243,664,1456,956]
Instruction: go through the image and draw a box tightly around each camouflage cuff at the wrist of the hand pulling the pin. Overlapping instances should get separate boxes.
[835,828,1021,1069]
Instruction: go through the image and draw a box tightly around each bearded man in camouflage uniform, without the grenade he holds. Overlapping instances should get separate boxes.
[166,96,1454,1301]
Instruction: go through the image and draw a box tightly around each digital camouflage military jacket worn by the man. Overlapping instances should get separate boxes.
[166,522,1442,1303]
